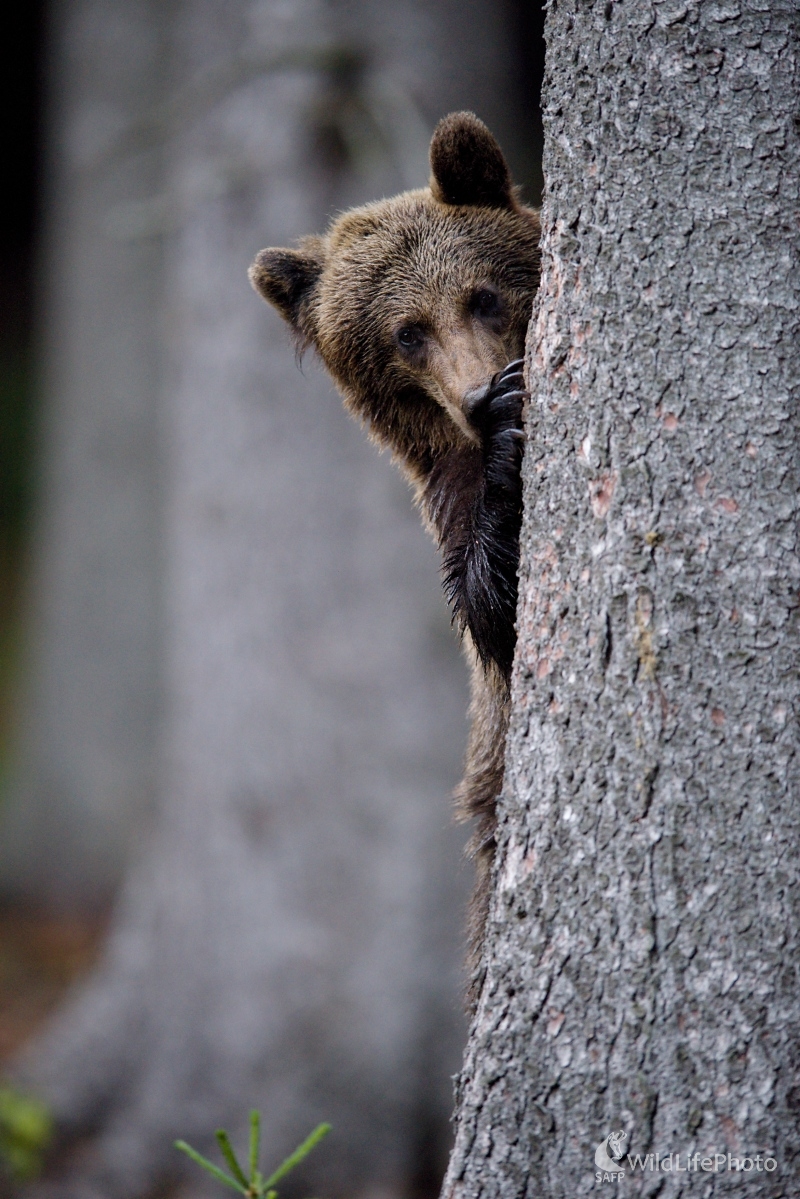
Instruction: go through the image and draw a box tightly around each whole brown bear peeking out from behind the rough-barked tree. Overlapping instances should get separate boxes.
[251,113,540,993]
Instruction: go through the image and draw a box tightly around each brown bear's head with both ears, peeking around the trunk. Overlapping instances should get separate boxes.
[251,113,540,478]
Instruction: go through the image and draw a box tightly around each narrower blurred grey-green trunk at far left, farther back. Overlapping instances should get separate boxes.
[0,0,165,906]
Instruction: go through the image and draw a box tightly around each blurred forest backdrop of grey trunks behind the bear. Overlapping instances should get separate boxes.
[0,0,543,1199]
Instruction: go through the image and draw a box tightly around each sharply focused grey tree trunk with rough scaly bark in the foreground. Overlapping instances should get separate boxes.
[444,0,800,1199]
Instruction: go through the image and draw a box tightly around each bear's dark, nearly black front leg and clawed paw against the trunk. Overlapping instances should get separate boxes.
[443,359,527,680]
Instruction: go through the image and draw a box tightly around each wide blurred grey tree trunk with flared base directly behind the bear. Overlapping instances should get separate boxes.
[9,0,537,1199]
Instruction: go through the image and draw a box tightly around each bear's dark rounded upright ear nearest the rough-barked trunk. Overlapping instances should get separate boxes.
[431,113,515,209]
